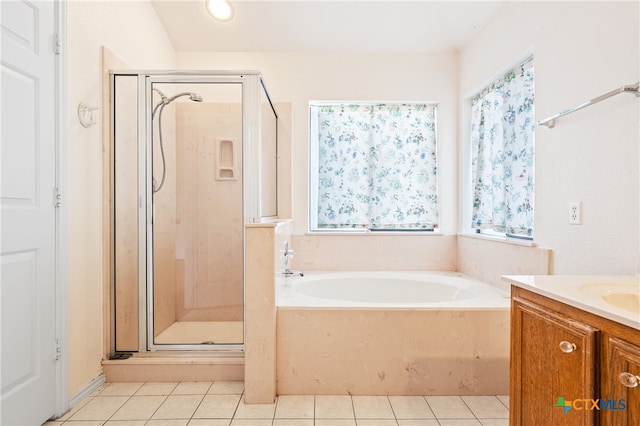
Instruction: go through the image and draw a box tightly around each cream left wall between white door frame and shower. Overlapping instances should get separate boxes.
[65,1,175,395]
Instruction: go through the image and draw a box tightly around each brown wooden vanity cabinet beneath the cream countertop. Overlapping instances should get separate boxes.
[509,286,640,426]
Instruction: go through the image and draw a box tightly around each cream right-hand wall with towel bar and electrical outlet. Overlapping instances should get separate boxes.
[460,1,640,274]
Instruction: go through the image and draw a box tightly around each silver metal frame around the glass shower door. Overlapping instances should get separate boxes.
[131,71,263,352]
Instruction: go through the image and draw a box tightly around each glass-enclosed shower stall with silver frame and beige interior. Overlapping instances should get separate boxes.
[109,71,278,357]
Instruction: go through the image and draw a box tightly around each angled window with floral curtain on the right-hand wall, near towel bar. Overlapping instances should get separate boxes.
[471,58,535,238]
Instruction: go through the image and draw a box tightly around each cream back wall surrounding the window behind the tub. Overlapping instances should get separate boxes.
[178,52,458,270]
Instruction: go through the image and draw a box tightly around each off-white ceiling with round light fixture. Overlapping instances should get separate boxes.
[152,0,506,53]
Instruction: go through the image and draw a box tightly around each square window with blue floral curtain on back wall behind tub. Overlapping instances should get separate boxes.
[310,102,438,231]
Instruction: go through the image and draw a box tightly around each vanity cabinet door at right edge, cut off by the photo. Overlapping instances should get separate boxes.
[601,337,640,426]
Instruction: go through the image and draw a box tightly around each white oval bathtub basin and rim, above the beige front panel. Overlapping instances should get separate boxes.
[277,271,509,309]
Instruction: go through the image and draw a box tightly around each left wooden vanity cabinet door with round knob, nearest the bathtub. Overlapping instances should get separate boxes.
[510,298,598,426]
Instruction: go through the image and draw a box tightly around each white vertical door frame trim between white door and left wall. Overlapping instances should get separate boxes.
[54,0,69,418]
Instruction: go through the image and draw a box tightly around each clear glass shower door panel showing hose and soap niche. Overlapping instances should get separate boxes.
[147,80,244,350]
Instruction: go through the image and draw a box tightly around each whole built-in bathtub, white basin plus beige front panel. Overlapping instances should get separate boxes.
[276,272,510,395]
